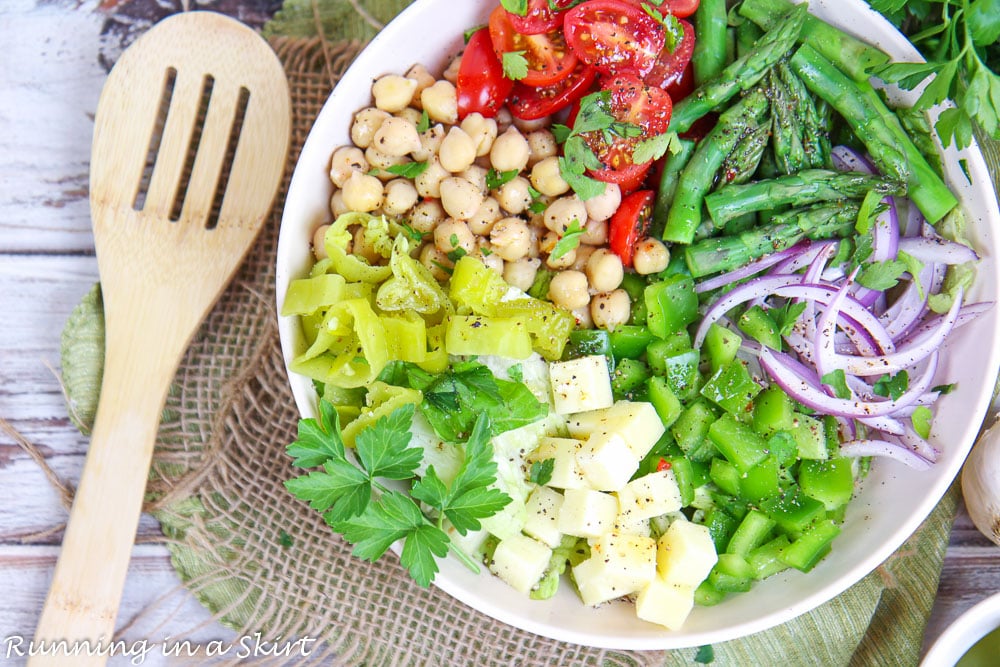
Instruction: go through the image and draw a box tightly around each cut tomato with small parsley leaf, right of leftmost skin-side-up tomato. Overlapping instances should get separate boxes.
[489,7,577,86]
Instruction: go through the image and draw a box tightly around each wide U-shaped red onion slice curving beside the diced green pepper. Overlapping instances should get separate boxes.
[759,348,938,418]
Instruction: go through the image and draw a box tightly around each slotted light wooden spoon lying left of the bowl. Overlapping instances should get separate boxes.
[32,12,291,666]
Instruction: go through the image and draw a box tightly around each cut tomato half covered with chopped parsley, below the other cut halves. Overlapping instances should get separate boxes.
[582,76,673,177]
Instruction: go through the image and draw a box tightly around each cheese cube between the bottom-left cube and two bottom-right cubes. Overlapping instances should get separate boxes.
[573,533,656,605]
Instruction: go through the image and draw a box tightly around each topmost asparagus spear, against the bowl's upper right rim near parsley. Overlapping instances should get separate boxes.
[739,0,889,81]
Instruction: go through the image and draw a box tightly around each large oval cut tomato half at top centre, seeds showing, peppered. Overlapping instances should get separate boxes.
[563,0,666,76]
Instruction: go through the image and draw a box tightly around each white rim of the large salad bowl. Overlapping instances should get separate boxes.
[276,0,1000,650]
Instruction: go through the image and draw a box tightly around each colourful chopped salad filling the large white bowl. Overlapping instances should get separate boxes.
[282,0,992,629]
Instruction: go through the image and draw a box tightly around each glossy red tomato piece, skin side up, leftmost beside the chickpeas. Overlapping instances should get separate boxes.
[456,28,514,118]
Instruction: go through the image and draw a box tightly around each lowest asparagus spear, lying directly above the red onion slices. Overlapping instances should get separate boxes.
[684,202,860,278]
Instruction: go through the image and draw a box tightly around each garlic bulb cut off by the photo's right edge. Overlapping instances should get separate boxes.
[962,415,1000,545]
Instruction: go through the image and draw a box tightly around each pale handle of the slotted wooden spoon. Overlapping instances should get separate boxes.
[29,314,188,667]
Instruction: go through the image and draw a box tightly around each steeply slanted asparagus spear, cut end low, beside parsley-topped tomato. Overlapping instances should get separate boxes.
[663,90,767,243]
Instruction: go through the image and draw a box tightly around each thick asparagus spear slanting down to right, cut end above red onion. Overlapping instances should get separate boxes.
[790,45,958,224]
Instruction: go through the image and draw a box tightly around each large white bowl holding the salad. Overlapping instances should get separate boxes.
[277,0,1000,649]
